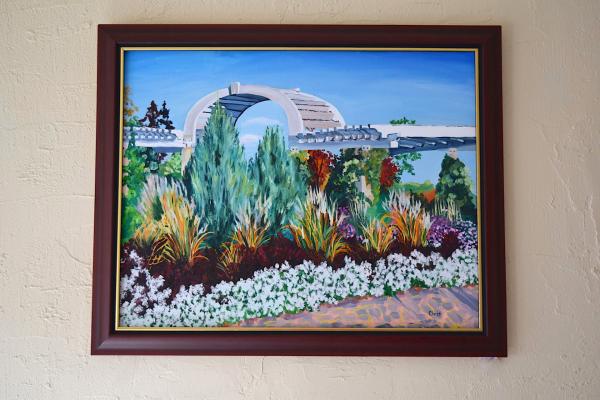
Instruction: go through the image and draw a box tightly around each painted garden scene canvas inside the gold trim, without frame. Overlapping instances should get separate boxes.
[116,49,481,330]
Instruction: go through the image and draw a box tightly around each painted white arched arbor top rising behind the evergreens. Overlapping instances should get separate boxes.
[183,82,345,146]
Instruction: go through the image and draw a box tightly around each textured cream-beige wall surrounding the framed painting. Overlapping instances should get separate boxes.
[0,0,600,400]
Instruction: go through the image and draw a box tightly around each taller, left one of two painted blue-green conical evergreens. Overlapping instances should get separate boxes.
[184,104,251,247]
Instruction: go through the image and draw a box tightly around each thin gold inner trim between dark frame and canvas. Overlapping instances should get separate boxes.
[114,46,484,333]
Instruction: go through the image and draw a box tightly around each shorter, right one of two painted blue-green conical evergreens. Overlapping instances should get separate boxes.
[248,127,306,235]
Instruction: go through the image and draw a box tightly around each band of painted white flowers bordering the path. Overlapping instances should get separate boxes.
[120,249,478,327]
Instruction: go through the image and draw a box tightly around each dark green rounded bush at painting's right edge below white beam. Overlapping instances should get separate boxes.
[435,155,477,220]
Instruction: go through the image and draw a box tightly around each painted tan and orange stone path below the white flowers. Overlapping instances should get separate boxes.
[238,286,479,328]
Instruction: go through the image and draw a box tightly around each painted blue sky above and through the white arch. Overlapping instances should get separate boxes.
[125,50,475,186]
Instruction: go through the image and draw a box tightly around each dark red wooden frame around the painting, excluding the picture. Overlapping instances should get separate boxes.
[91,25,507,357]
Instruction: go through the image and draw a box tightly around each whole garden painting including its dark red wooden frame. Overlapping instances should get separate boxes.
[92,25,506,356]
